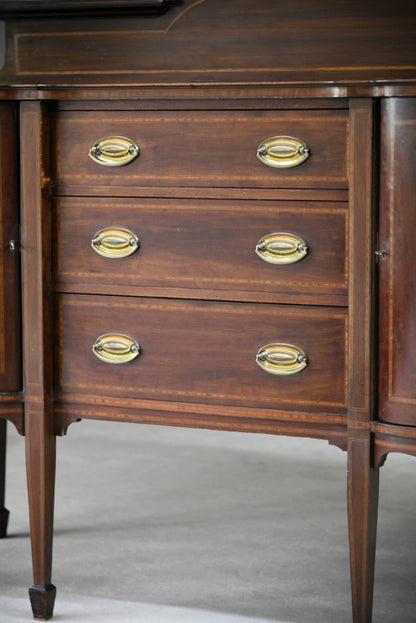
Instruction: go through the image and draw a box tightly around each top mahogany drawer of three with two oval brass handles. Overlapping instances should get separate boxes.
[54,110,348,190]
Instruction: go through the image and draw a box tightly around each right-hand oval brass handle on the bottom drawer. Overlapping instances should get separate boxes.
[256,343,308,376]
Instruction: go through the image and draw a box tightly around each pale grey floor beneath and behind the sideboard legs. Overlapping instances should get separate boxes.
[0,421,416,623]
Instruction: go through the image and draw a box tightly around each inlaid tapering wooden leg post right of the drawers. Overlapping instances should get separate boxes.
[347,99,379,623]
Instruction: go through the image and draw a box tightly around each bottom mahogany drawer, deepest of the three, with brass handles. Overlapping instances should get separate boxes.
[55,294,347,415]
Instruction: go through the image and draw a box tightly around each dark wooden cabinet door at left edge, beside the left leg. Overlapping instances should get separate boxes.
[0,102,21,393]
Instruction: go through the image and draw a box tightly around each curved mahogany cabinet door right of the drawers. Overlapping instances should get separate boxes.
[378,98,416,425]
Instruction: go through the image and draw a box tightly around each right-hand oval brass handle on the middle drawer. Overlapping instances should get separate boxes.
[255,232,309,264]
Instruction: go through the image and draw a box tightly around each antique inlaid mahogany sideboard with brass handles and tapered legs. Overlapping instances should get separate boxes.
[0,0,416,623]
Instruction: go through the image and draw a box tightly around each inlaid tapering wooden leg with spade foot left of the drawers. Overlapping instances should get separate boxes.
[20,102,56,620]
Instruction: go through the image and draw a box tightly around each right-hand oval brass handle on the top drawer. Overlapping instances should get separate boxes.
[257,136,309,169]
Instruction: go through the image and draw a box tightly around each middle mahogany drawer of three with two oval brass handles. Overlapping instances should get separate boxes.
[54,198,347,301]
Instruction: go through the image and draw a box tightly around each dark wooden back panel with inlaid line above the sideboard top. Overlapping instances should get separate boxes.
[0,0,416,95]
